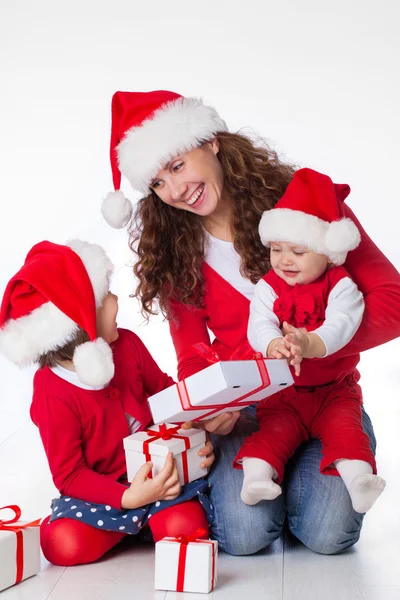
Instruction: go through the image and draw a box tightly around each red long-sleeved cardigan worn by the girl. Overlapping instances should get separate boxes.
[31,329,174,509]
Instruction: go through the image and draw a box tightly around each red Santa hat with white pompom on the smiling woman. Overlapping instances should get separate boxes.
[101,90,227,229]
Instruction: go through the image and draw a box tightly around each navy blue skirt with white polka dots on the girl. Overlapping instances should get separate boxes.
[50,479,214,535]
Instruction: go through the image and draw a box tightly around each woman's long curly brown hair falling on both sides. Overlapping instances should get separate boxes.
[129,132,294,319]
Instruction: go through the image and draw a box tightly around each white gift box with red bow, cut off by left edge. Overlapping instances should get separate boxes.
[0,505,40,591]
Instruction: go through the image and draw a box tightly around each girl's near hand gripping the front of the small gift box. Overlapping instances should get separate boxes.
[121,452,181,509]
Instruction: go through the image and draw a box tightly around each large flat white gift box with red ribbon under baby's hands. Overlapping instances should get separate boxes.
[148,358,293,423]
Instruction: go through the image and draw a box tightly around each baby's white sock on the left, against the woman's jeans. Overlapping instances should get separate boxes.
[240,458,282,505]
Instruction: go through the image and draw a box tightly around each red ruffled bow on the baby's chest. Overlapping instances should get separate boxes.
[274,285,325,327]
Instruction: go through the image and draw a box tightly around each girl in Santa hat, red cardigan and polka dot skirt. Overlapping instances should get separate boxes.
[0,240,214,566]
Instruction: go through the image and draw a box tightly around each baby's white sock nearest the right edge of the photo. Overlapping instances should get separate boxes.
[334,458,386,513]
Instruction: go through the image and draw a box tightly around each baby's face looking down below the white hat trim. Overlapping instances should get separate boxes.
[271,242,329,285]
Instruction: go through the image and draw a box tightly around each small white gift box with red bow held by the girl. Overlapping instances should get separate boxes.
[124,423,207,485]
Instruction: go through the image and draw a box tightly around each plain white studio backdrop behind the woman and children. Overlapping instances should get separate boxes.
[0,0,400,424]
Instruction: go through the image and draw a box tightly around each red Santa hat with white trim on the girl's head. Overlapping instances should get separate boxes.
[0,240,114,386]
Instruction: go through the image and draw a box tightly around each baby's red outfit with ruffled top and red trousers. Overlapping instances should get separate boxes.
[233,267,376,483]
